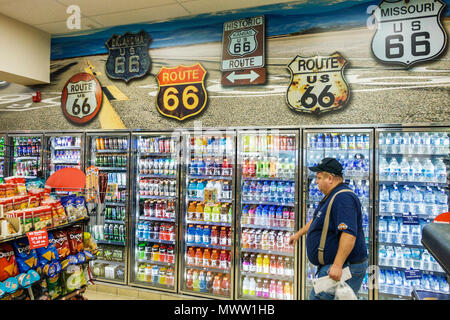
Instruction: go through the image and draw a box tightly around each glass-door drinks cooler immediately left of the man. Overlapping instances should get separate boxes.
[236,129,299,300]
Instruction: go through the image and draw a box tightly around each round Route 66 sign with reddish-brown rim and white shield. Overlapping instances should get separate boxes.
[61,72,103,124]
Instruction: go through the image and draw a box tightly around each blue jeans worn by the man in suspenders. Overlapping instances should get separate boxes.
[309,259,369,300]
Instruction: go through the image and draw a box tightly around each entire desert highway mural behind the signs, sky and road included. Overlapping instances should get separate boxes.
[0,0,450,130]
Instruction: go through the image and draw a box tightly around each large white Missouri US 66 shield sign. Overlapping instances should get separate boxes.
[372,0,447,68]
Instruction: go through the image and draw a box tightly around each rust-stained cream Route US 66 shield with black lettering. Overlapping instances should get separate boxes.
[286,52,350,114]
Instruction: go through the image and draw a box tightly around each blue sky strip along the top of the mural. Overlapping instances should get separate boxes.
[51,0,450,60]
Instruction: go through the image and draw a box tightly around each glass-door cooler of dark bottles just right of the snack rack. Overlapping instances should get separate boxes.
[85,131,130,283]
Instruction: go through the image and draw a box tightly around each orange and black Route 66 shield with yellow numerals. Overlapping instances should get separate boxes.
[156,63,207,121]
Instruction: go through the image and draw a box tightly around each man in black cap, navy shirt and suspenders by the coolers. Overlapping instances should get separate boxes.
[290,158,368,300]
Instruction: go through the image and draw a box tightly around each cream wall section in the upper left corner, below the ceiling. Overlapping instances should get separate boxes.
[0,14,50,85]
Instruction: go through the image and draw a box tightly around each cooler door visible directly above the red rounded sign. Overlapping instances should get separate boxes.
[44,132,84,179]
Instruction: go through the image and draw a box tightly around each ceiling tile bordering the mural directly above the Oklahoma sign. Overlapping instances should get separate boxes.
[90,4,190,27]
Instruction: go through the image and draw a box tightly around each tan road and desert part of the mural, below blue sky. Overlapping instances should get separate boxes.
[0,20,450,130]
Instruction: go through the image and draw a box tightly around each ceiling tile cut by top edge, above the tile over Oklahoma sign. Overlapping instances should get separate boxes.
[57,0,177,17]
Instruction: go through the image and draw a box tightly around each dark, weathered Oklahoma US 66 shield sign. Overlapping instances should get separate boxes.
[106,31,151,82]
